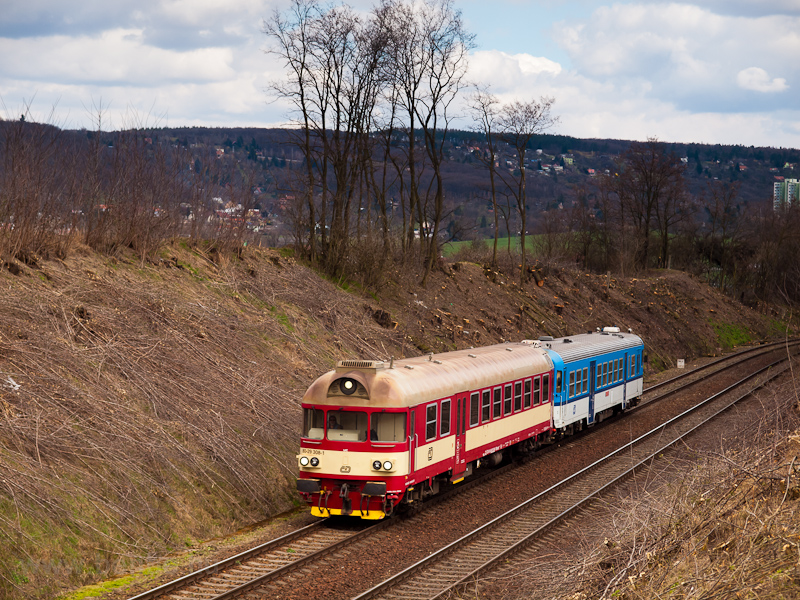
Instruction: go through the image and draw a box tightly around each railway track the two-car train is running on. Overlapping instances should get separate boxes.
[125,342,798,600]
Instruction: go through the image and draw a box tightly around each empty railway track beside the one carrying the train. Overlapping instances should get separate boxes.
[355,360,783,600]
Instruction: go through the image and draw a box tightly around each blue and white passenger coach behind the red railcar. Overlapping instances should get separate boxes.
[540,327,644,435]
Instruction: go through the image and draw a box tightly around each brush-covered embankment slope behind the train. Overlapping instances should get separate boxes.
[0,242,787,598]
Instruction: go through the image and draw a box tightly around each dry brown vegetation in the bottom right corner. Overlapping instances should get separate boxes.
[570,382,800,600]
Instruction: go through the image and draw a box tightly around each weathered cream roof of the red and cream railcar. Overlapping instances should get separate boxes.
[303,341,553,408]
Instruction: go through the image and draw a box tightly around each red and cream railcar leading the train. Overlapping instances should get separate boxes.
[297,341,553,519]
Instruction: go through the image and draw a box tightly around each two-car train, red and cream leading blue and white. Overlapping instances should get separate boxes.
[297,327,644,519]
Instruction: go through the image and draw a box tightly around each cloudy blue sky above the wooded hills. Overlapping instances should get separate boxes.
[0,0,800,148]
